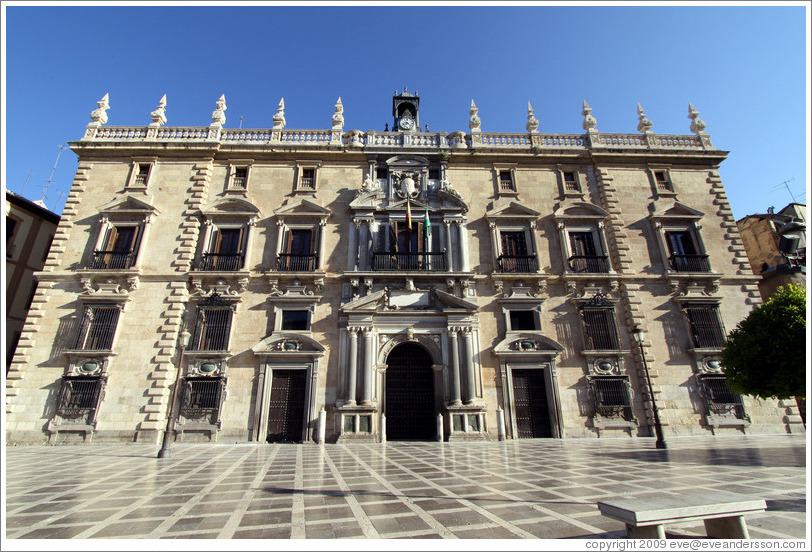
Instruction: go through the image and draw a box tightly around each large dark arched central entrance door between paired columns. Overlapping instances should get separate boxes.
[386,343,437,441]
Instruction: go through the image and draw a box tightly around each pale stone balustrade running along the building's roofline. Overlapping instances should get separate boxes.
[76,125,715,152]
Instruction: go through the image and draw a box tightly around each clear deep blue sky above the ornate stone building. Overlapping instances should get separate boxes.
[3,3,810,219]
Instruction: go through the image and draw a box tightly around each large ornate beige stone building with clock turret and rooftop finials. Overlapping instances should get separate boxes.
[7,90,803,443]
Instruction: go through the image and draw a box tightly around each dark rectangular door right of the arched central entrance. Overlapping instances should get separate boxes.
[512,370,553,438]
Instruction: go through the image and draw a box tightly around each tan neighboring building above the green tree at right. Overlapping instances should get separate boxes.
[737,203,806,300]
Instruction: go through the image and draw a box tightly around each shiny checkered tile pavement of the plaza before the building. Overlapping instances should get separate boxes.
[6,436,807,539]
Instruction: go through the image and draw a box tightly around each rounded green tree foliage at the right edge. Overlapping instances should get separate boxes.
[722,285,806,399]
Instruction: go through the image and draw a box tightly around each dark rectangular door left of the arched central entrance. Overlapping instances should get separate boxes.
[268,370,307,442]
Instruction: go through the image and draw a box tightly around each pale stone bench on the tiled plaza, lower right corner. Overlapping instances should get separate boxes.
[598,490,767,539]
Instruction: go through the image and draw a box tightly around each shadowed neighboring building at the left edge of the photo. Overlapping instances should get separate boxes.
[4,191,59,371]
